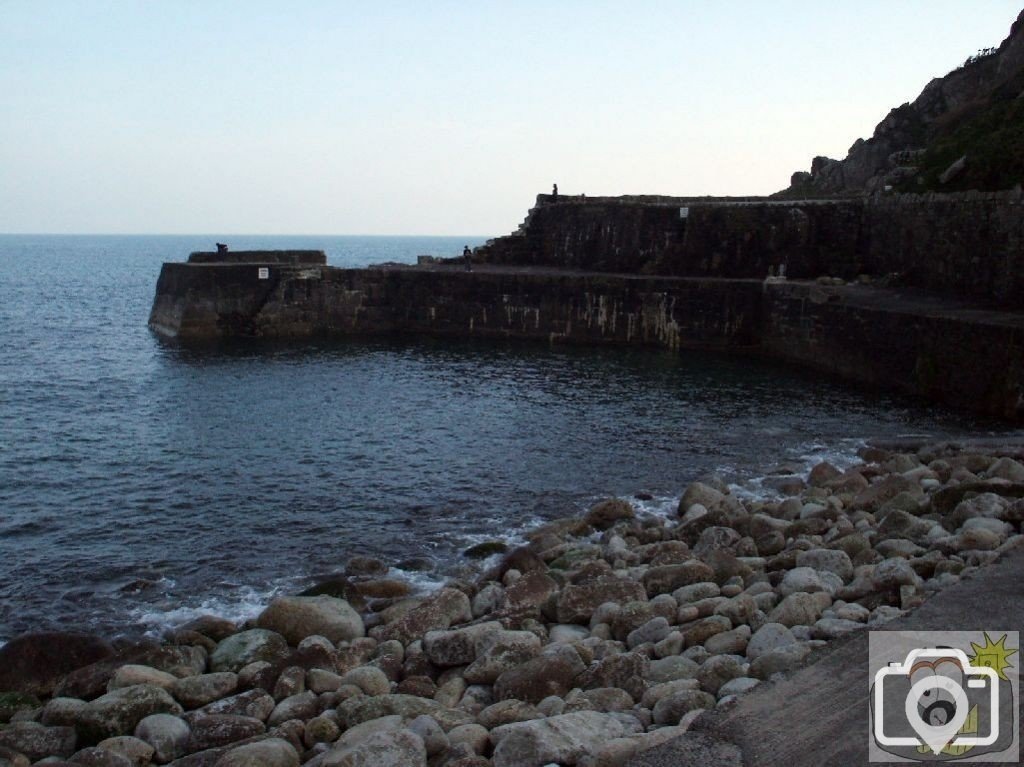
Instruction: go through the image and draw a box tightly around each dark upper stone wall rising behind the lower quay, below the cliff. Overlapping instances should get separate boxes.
[477,191,1024,305]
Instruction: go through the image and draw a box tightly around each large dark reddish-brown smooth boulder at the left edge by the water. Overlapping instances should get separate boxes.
[0,632,115,696]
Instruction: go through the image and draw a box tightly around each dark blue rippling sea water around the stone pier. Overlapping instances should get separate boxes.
[0,236,1015,641]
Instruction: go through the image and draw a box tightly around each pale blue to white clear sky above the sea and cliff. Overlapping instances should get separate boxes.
[0,0,1022,236]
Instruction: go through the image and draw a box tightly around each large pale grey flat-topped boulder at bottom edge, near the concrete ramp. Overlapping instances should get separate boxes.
[490,711,639,767]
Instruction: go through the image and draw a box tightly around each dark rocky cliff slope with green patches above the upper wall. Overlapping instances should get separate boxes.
[777,11,1024,198]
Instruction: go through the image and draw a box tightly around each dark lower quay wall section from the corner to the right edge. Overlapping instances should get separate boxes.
[760,284,1024,420]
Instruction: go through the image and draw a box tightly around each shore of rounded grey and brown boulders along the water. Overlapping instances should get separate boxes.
[0,444,1024,767]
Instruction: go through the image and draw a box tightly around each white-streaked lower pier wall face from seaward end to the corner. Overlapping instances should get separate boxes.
[150,263,761,348]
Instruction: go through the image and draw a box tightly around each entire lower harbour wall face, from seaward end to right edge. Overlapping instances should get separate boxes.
[150,263,1024,421]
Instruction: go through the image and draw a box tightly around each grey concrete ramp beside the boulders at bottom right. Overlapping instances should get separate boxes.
[629,546,1024,767]
